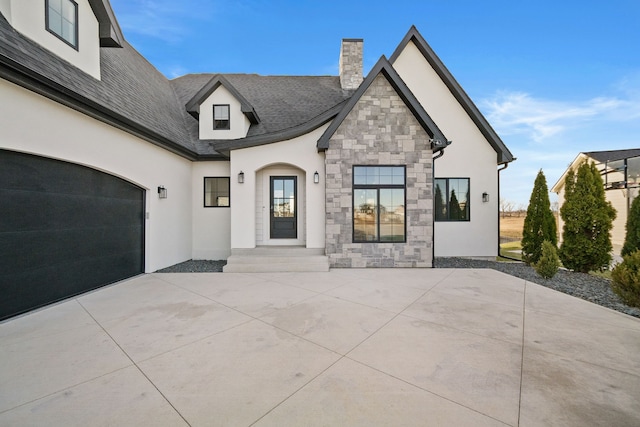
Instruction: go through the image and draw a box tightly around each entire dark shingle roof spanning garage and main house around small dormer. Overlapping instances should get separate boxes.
[0,8,350,159]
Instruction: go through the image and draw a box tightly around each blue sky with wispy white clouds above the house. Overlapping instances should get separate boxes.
[111,0,640,208]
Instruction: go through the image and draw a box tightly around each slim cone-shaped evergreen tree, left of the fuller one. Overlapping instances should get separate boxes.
[522,169,558,264]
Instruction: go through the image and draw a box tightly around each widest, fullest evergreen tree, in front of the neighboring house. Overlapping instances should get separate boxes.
[559,162,616,273]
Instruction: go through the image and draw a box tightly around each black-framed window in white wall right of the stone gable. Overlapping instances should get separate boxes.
[434,178,471,221]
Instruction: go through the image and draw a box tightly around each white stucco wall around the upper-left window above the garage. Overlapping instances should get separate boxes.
[0,0,100,80]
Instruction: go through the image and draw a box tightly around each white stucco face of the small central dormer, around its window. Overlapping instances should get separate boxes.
[199,86,251,139]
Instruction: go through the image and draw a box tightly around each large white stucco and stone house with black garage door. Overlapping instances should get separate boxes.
[0,0,514,317]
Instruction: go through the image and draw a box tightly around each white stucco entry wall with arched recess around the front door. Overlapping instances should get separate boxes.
[231,125,328,248]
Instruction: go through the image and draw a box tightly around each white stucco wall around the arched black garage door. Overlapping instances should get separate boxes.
[0,79,192,272]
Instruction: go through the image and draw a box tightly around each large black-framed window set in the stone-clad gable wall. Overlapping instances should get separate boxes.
[353,166,407,243]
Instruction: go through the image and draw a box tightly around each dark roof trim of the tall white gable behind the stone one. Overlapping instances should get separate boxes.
[389,25,515,163]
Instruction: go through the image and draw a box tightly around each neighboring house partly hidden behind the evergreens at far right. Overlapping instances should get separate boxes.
[551,148,640,254]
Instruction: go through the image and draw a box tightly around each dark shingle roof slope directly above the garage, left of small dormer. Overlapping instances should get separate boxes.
[0,14,196,157]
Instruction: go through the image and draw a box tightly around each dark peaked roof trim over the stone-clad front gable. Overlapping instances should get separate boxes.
[317,55,450,151]
